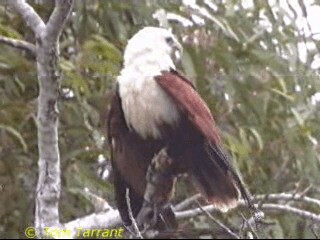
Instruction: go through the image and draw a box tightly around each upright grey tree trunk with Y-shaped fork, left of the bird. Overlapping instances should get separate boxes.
[3,0,73,236]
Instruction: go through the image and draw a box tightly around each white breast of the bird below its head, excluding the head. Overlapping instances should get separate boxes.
[118,65,179,139]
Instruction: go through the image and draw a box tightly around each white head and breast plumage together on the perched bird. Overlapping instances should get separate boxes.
[117,27,182,139]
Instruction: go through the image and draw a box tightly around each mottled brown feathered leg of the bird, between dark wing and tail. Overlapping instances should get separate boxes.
[137,149,176,227]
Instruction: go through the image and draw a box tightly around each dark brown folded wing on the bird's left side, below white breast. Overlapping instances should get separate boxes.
[107,87,144,225]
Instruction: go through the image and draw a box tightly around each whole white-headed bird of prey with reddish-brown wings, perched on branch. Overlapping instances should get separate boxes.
[107,26,250,229]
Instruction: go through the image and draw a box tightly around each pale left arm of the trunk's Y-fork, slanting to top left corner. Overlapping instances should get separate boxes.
[7,0,46,36]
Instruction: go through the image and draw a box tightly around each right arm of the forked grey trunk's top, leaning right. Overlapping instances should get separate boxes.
[46,0,73,42]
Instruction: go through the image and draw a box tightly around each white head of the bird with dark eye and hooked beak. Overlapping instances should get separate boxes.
[124,27,182,67]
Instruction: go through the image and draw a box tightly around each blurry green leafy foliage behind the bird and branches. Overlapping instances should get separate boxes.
[0,0,320,238]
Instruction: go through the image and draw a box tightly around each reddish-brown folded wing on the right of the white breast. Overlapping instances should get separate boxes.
[155,70,251,208]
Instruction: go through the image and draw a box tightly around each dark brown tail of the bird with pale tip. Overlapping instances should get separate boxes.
[190,143,251,211]
